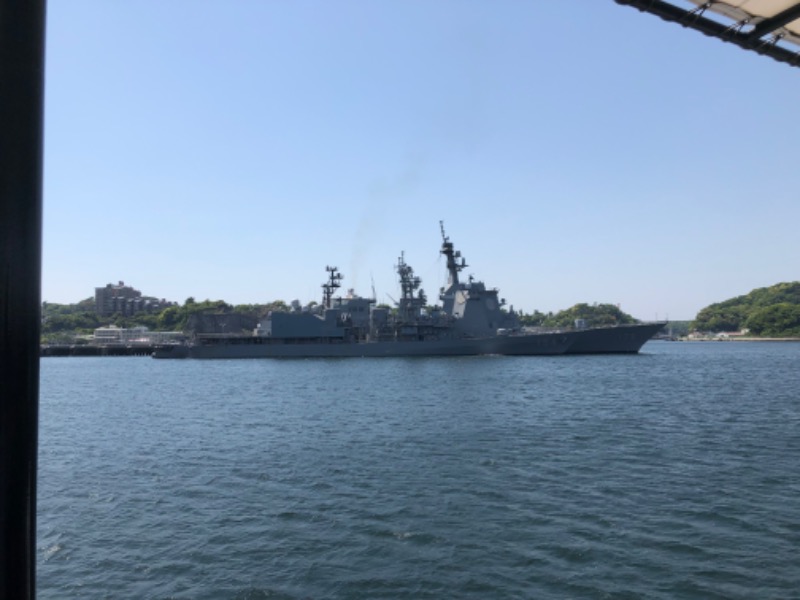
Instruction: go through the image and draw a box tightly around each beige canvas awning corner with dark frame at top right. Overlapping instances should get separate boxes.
[615,0,800,67]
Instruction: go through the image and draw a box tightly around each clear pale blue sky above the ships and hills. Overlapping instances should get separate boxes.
[42,0,800,320]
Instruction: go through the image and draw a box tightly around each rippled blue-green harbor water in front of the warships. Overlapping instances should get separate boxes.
[37,342,800,600]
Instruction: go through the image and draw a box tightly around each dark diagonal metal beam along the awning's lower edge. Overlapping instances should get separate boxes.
[614,0,800,67]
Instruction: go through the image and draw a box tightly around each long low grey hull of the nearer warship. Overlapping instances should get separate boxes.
[153,332,578,358]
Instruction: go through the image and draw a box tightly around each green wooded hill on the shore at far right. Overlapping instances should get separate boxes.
[692,281,800,337]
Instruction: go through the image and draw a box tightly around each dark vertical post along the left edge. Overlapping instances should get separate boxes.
[0,0,45,599]
